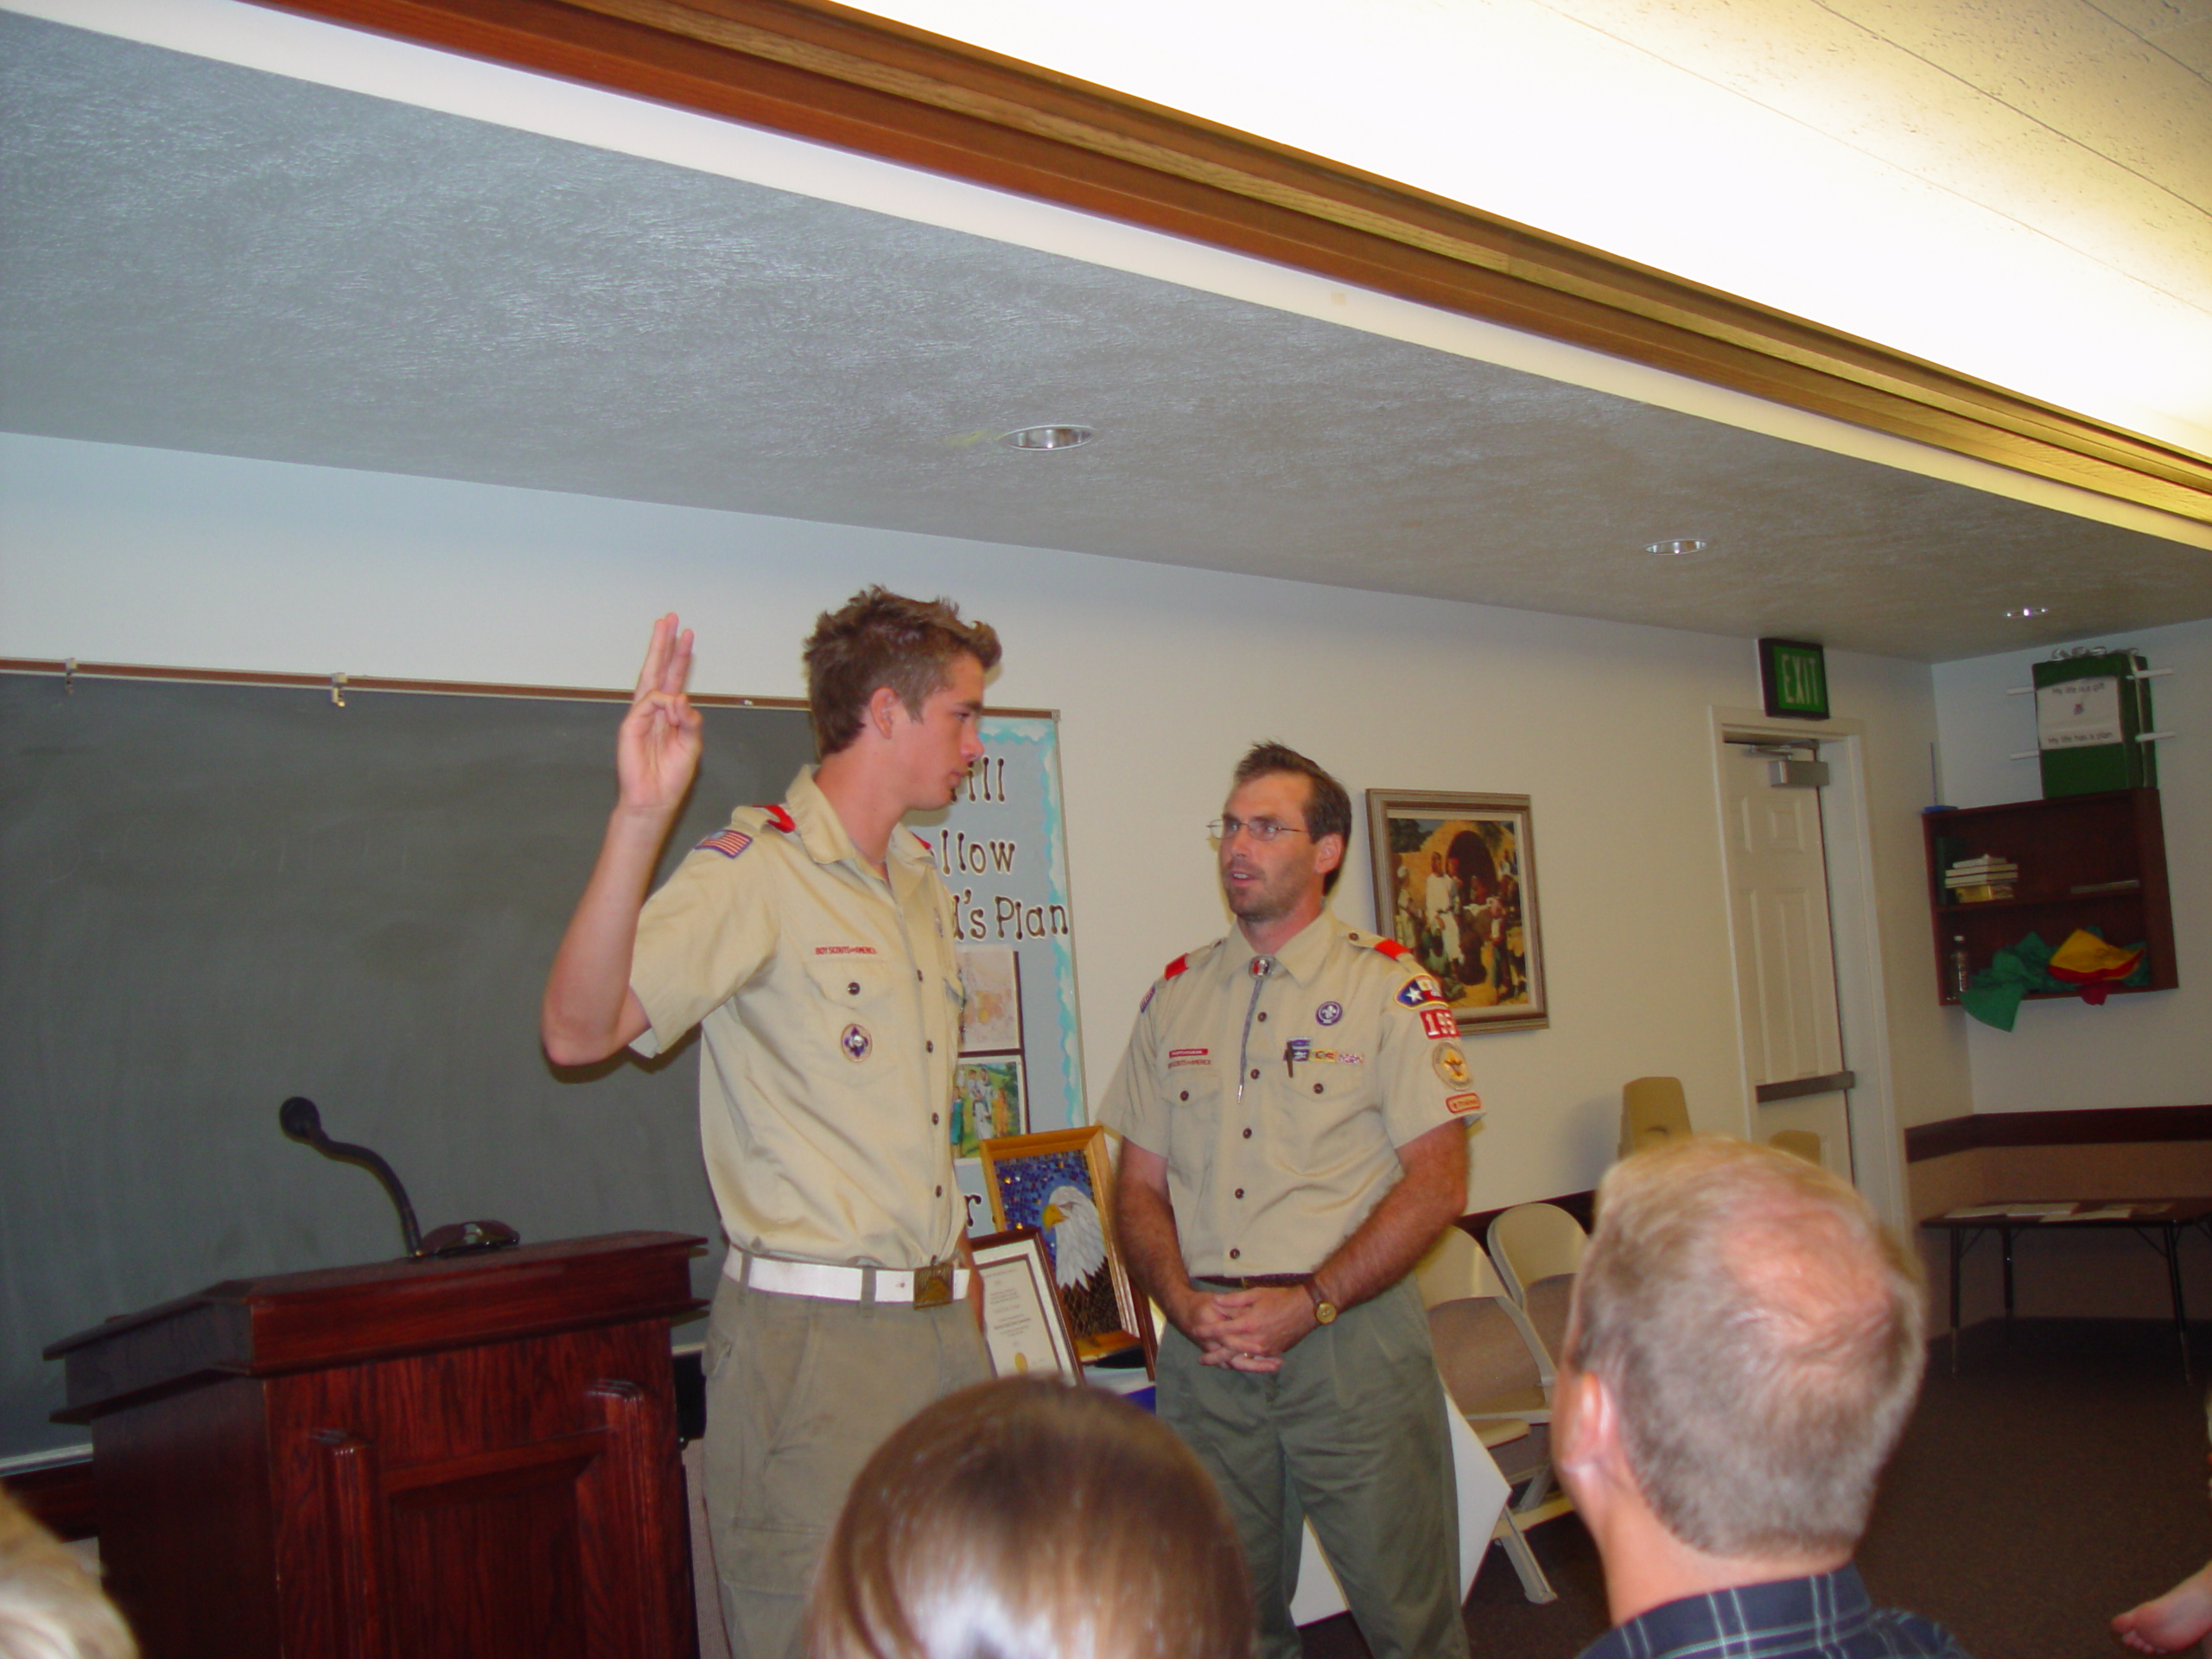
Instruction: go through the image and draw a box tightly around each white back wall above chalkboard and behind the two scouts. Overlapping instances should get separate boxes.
[0,438,1968,1208]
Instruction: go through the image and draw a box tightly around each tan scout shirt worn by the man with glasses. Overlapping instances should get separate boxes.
[1099,913,1482,1276]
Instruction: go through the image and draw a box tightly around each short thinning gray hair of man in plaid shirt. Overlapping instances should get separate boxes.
[1566,1135,1927,1557]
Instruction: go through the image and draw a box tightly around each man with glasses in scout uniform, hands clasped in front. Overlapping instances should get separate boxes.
[1099,743,1482,1659]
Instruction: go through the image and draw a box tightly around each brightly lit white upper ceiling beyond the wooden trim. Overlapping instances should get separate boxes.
[869,0,2212,454]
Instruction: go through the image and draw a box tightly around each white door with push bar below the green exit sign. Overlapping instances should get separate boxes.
[1721,739,1852,1179]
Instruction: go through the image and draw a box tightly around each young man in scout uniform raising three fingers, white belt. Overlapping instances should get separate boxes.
[542,588,1000,1659]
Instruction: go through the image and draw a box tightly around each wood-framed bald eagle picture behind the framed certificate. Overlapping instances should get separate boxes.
[982,1123,1157,1371]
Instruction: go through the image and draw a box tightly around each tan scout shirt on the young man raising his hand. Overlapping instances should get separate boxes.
[631,766,963,1268]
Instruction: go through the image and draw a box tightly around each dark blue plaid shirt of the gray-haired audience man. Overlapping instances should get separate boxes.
[1581,1561,1967,1659]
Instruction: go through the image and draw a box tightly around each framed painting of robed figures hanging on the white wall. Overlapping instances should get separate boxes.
[1367,790,1551,1035]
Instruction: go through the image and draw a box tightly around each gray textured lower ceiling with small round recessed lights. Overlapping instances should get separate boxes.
[0,13,2212,659]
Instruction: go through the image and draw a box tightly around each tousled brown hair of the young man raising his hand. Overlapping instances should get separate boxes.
[805,586,1000,757]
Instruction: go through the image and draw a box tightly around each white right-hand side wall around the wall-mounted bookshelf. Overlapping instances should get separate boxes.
[1936,621,2212,1113]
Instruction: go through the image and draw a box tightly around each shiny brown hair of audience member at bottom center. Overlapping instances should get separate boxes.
[807,1378,1256,1659]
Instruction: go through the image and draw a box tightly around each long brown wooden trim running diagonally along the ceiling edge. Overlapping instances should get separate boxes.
[242,0,2212,522]
